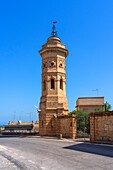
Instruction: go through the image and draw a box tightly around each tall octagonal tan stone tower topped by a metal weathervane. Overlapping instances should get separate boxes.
[39,22,68,136]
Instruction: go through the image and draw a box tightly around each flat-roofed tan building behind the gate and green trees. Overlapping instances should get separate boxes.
[76,97,105,112]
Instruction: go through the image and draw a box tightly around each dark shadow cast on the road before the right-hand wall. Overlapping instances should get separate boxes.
[64,143,113,157]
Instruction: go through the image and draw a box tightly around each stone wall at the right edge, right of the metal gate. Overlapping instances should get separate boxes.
[90,111,113,142]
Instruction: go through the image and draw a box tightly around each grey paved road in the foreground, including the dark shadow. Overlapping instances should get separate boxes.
[0,137,113,170]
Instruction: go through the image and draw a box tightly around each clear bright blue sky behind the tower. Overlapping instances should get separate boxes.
[0,0,113,124]
